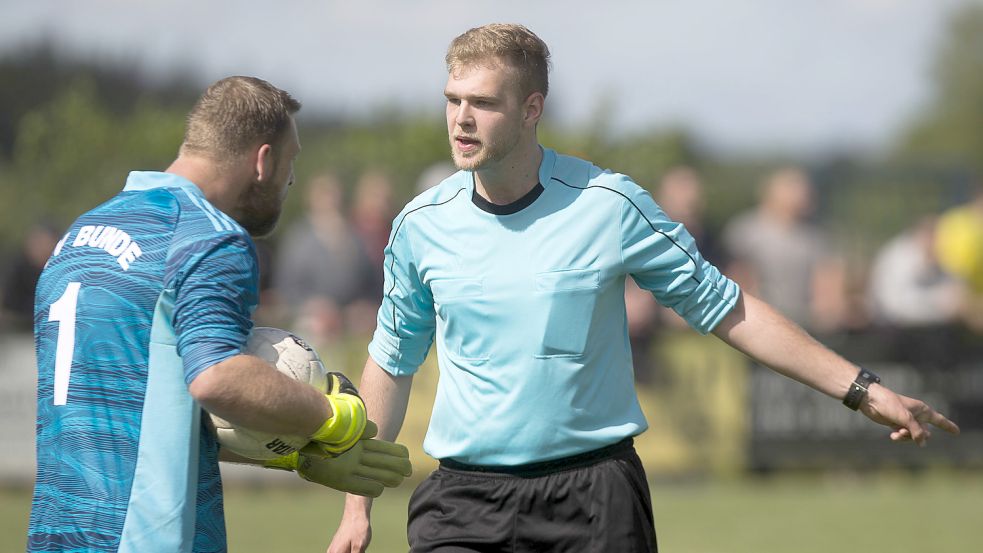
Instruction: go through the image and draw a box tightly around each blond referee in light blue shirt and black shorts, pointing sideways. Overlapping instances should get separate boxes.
[329,24,958,553]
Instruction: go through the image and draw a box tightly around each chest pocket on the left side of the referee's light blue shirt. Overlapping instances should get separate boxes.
[430,278,488,362]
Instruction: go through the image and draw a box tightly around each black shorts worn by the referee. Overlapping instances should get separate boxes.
[408,438,657,553]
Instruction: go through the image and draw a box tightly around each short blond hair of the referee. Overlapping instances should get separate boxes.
[444,23,550,96]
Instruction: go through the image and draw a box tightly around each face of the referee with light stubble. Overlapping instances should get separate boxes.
[444,62,523,171]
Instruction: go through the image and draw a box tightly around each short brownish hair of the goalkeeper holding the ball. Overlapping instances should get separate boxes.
[181,76,300,160]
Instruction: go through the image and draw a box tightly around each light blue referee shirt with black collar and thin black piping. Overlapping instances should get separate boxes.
[369,149,740,465]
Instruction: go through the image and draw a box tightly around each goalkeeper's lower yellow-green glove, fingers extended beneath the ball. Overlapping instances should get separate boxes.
[264,422,413,497]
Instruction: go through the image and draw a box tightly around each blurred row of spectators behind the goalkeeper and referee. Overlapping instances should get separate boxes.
[0,163,983,383]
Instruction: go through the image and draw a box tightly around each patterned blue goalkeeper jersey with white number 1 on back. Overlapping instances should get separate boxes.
[27,172,258,553]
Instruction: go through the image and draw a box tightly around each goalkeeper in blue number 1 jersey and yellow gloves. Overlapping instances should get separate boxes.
[27,77,409,553]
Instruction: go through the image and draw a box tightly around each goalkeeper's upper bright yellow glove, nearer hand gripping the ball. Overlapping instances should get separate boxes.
[310,372,368,456]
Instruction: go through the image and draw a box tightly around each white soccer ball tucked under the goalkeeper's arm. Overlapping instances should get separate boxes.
[210,326,328,461]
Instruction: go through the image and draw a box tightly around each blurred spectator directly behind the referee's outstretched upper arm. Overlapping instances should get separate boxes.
[625,166,719,383]
